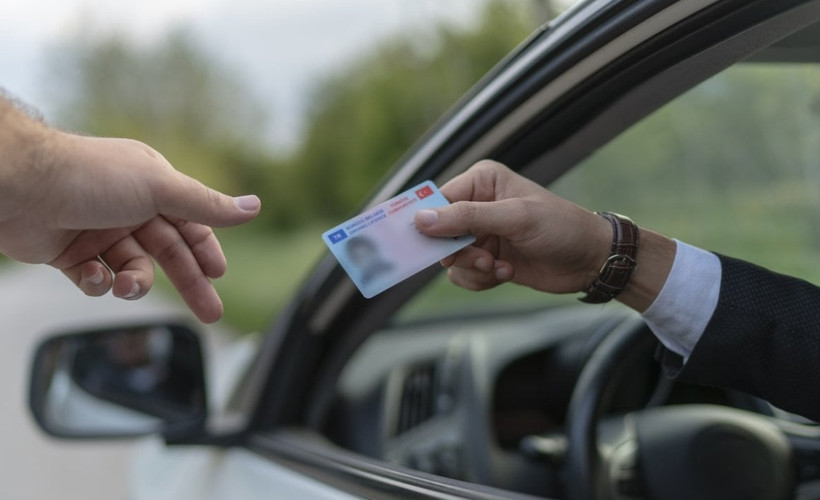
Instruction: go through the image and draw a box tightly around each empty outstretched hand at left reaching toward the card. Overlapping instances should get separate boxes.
[0,123,261,322]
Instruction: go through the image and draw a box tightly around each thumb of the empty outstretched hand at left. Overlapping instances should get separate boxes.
[155,171,262,227]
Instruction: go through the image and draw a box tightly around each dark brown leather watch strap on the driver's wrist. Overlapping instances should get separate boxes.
[578,212,640,304]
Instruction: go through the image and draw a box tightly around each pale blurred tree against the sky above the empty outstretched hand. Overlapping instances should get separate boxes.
[47,25,302,222]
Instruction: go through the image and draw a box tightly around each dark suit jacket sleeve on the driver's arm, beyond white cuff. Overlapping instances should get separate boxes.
[662,256,820,421]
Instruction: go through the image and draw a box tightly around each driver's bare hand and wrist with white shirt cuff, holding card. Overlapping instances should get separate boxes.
[416,162,721,360]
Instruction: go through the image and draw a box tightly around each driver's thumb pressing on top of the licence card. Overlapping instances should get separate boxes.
[414,200,514,237]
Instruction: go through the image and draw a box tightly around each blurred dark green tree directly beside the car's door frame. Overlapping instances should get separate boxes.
[295,1,535,219]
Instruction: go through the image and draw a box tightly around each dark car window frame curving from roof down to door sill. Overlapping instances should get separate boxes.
[183,0,820,498]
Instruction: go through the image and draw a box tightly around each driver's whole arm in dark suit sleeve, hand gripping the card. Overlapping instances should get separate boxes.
[415,161,820,420]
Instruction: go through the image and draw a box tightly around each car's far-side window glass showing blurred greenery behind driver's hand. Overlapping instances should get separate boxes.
[398,63,820,322]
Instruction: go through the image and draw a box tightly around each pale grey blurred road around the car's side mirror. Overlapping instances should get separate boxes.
[0,264,188,500]
